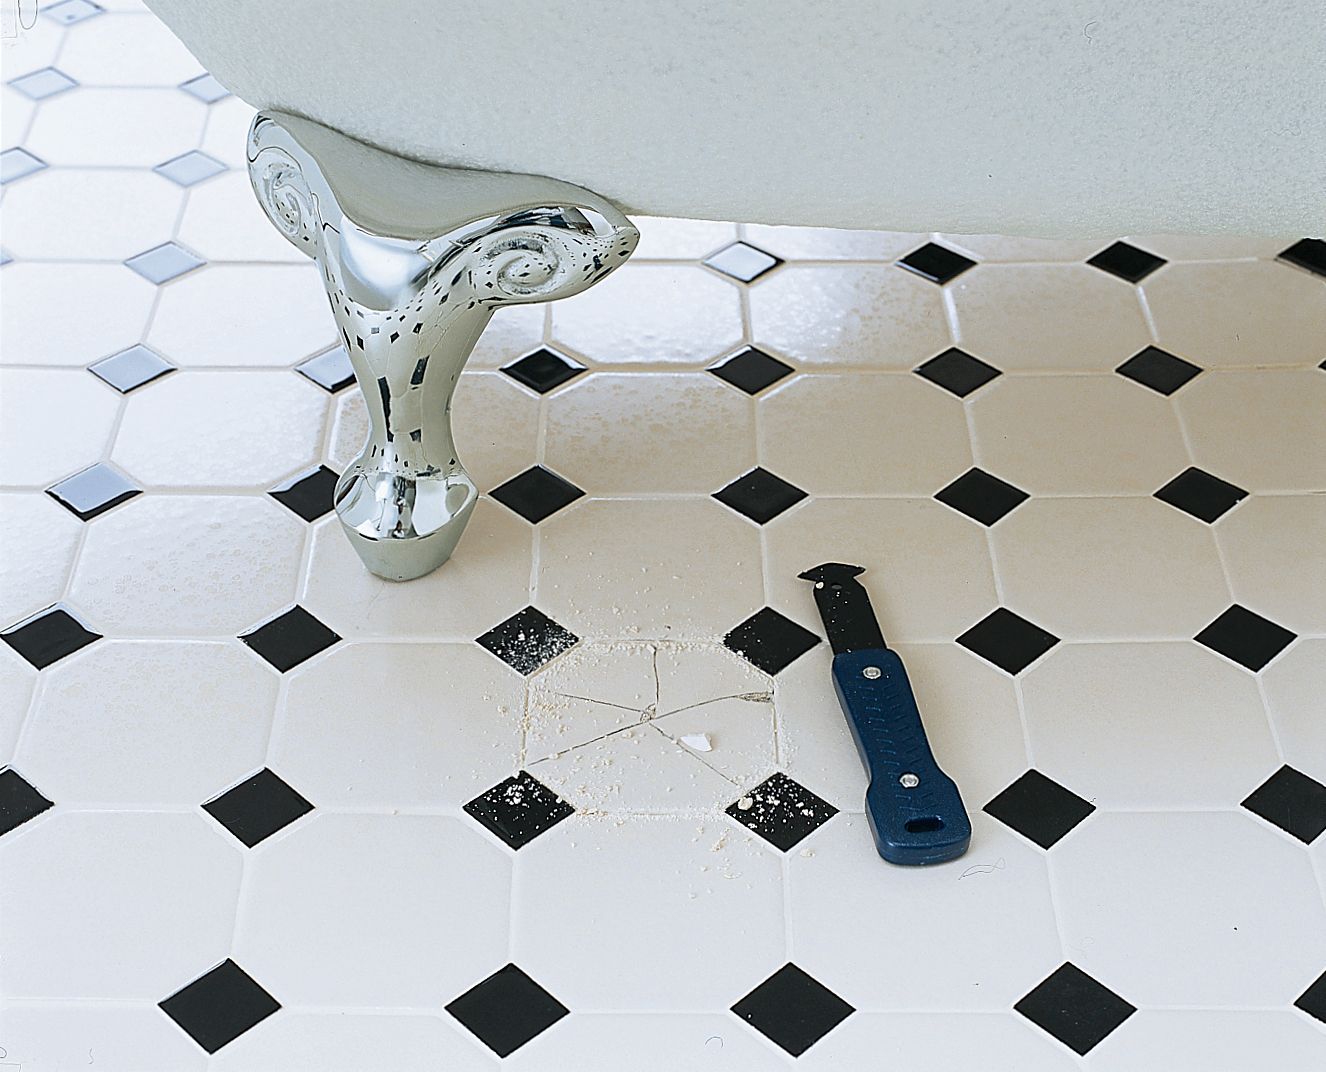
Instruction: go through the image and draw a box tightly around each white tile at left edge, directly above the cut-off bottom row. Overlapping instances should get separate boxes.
[0,812,240,1003]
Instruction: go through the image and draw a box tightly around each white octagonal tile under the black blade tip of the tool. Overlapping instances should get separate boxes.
[765,499,998,642]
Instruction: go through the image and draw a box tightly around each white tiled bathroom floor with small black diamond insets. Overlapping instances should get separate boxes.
[0,0,1326,1072]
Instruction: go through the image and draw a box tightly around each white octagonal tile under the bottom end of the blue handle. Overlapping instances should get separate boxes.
[788,812,1059,1011]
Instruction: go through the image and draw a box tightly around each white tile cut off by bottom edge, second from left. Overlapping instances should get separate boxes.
[209,1010,499,1072]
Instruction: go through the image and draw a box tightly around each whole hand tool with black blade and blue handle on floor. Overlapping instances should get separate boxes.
[801,563,972,864]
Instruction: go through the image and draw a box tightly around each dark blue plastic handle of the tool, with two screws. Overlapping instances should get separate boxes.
[833,649,972,865]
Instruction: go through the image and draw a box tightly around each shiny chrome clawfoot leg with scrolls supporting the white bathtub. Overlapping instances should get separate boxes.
[248,111,639,581]
